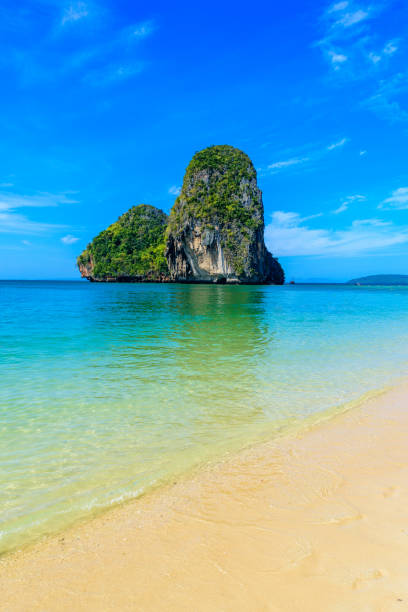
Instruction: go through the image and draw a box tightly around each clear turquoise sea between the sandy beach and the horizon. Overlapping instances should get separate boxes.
[0,282,408,551]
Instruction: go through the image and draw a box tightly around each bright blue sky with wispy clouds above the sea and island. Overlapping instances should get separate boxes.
[0,0,408,281]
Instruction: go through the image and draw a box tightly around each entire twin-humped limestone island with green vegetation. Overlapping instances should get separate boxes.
[77,145,285,285]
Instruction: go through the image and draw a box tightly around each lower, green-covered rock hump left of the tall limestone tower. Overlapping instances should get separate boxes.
[77,204,170,282]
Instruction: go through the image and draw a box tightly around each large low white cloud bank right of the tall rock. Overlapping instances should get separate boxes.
[265,211,408,257]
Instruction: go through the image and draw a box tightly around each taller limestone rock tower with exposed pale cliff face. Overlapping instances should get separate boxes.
[166,145,284,284]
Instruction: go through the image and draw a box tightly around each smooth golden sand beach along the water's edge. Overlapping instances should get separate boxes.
[0,385,408,612]
